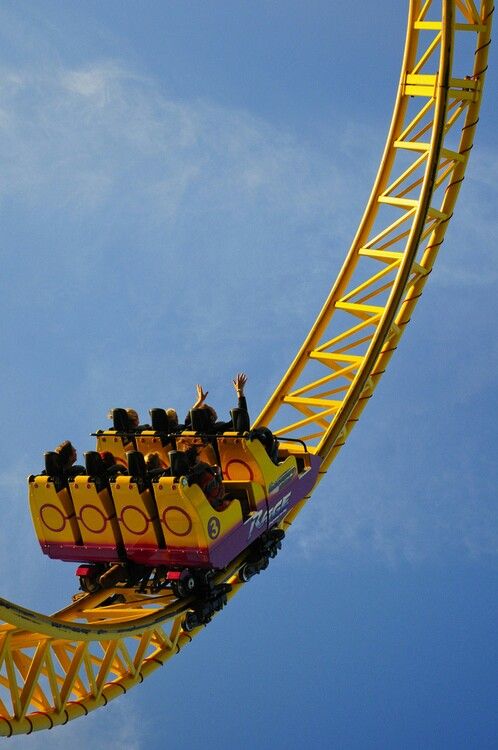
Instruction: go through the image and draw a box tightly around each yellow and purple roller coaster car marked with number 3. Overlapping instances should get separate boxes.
[29,431,320,594]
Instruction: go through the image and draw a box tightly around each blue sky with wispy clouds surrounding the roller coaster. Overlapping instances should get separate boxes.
[0,0,498,750]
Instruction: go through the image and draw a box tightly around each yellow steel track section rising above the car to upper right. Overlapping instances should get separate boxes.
[255,0,493,473]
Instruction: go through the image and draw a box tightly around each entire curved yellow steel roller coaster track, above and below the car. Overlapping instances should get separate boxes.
[0,0,493,736]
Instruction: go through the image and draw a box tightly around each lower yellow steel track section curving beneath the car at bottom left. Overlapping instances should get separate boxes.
[0,559,243,737]
